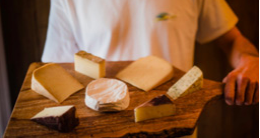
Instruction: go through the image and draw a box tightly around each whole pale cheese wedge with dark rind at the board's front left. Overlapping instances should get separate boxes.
[31,106,79,132]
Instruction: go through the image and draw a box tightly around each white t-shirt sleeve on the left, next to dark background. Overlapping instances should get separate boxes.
[41,0,78,62]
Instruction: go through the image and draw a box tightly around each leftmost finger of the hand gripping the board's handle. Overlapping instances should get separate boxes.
[224,75,236,105]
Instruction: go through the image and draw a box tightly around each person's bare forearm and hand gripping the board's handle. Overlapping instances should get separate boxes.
[215,27,259,105]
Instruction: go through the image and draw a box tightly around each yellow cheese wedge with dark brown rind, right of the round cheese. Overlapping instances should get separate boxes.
[134,95,176,122]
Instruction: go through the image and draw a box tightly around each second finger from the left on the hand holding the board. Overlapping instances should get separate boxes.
[236,77,249,105]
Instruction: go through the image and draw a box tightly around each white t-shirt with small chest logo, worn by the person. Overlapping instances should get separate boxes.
[42,0,238,71]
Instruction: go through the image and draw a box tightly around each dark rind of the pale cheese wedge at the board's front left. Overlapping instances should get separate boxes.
[31,107,79,132]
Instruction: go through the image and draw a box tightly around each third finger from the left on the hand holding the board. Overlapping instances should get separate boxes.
[245,82,256,105]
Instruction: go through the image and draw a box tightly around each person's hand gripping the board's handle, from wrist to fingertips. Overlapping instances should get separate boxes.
[223,55,259,105]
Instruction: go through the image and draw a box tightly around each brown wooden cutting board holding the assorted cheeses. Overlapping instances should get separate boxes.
[4,61,223,137]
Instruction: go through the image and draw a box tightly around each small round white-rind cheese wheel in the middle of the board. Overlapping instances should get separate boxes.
[85,78,130,112]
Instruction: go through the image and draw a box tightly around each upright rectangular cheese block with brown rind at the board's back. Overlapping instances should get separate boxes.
[74,51,106,79]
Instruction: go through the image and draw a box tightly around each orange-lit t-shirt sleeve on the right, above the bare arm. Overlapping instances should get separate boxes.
[196,0,238,43]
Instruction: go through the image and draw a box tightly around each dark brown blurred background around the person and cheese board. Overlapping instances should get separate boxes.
[0,0,259,138]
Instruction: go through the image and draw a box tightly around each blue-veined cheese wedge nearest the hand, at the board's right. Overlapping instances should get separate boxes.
[167,66,203,100]
